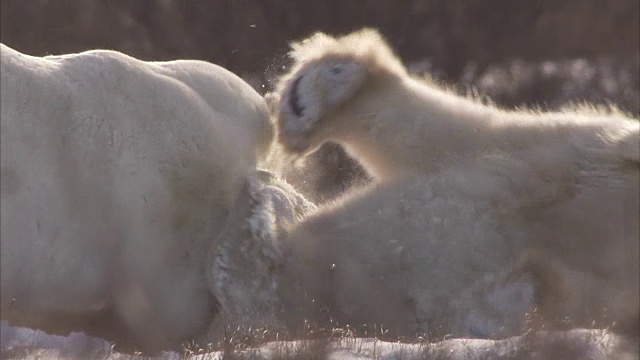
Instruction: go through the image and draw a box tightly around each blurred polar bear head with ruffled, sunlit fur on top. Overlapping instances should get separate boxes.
[273,29,406,155]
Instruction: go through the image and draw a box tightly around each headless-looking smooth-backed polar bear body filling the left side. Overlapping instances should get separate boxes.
[0,45,273,347]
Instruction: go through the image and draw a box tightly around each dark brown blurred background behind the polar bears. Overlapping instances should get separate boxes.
[0,0,640,202]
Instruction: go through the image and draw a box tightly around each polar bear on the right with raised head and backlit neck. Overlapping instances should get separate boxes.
[227,30,640,336]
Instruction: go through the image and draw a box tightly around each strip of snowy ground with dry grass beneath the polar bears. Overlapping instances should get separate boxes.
[0,321,638,360]
